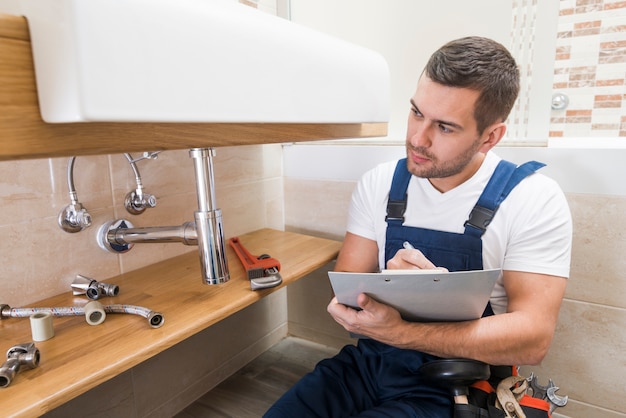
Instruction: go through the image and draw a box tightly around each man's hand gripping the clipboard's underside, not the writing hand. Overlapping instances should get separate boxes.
[327,293,403,343]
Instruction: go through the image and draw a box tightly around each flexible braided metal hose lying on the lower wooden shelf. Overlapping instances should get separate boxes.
[0,301,164,328]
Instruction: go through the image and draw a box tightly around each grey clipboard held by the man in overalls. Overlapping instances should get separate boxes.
[328,269,502,322]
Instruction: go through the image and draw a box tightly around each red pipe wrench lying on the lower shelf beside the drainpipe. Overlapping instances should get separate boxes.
[228,237,283,290]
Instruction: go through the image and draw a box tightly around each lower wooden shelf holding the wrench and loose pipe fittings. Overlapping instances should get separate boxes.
[0,229,341,417]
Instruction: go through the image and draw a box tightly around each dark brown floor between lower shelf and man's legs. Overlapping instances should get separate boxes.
[175,337,337,418]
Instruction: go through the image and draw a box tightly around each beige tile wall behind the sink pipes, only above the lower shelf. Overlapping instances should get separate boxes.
[0,145,283,307]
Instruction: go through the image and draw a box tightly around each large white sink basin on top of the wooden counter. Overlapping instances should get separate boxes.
[0,0,389,123]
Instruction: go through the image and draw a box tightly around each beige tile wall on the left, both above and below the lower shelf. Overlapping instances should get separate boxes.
[0,145,287,417]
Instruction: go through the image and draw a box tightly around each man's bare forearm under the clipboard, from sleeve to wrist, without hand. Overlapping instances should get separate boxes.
[394,271,567,365]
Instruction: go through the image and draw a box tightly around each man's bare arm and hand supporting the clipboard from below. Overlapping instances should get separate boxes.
[328,250,567,365]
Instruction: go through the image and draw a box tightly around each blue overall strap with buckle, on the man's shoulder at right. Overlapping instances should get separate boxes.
[464,160,545,237]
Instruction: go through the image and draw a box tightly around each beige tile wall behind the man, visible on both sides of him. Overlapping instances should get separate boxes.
[284,177,626,418]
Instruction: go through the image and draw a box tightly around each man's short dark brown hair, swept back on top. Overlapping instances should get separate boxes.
[424,36,519,133]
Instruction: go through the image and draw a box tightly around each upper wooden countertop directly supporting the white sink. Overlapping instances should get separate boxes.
[0,13,387,161]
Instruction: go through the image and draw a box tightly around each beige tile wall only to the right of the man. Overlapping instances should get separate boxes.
[524,194,626,418]
